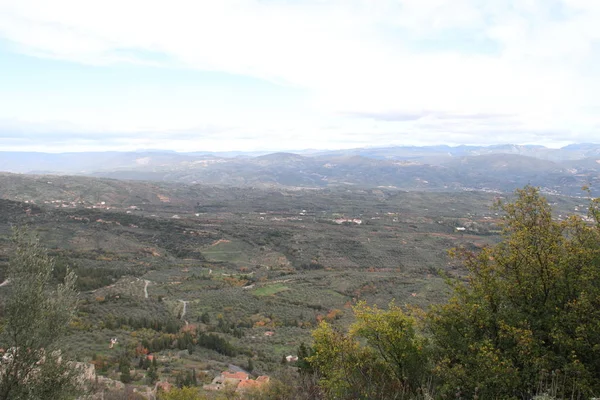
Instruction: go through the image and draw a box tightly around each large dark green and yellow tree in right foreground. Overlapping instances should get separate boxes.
[429,187,600,399]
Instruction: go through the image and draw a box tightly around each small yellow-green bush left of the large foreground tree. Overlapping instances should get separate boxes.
[308,302,430,399]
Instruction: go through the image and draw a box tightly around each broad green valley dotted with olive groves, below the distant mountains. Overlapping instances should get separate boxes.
[0,174,586,396]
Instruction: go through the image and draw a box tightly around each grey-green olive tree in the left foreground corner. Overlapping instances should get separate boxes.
[0,229,79,400]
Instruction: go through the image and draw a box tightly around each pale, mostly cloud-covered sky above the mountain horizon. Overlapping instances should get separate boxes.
[0,0,600,152]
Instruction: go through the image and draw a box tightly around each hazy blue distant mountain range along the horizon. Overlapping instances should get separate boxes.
[0,144,600,196]
